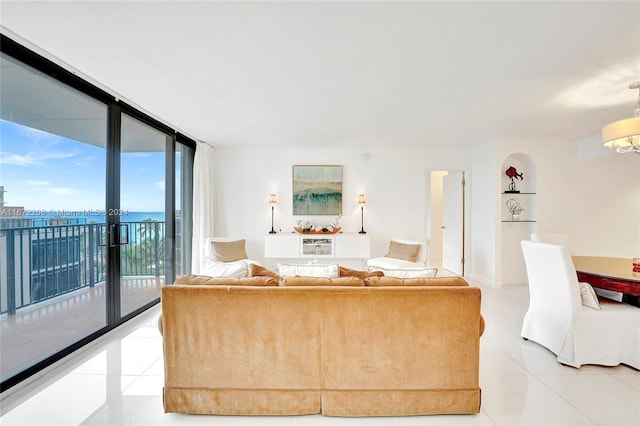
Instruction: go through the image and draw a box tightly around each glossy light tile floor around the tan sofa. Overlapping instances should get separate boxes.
[0,280,640,426]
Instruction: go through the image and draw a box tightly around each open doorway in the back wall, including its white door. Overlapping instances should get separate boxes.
[429,170,465,276]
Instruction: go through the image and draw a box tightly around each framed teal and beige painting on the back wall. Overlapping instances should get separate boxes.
[291,164,343,216]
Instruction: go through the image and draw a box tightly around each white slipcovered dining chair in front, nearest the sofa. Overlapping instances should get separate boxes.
[521,241,640,369]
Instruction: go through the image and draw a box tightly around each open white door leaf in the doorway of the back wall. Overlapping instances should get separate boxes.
[442,172,464,275]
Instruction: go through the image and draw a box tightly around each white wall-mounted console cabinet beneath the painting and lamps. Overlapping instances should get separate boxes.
[264,233,369,259]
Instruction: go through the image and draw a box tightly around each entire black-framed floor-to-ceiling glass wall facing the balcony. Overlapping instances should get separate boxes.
[0,35,195,390]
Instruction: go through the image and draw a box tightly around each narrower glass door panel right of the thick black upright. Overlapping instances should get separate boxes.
[113,113,172,316]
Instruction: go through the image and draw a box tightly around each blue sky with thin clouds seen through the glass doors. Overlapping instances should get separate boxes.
[0,120,165,212]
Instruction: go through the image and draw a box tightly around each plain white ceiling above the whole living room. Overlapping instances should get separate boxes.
[0,0,640,148]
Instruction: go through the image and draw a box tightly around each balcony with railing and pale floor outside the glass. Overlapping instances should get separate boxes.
[0,221,165,381]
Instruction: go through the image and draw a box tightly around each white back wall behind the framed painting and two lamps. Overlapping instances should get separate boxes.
[215,148,468,266]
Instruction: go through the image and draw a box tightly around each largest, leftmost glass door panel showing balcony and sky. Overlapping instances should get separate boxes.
[0,54,109,382]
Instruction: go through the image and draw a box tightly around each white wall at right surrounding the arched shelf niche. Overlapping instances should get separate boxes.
[471,138,640,287]
